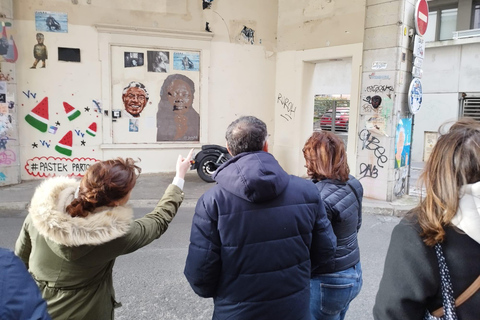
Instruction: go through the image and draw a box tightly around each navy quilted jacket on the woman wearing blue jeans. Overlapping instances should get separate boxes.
[314,176,363,274]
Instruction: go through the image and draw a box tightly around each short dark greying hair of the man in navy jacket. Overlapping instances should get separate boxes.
[225,116,267,156]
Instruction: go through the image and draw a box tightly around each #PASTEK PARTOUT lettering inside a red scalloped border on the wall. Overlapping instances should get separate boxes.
[24,157,100,178]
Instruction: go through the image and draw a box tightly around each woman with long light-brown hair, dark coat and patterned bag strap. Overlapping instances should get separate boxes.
[373,119,480,320]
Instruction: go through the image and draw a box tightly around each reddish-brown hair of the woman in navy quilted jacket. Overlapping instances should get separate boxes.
[302,131,350,182]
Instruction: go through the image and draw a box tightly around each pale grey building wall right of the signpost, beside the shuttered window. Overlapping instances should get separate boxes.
[412,38,480,161]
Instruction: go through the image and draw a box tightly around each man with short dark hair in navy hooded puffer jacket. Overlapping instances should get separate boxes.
[185,117,336,320]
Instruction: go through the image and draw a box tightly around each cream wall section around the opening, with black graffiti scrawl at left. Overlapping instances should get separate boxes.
[273,0,365,175]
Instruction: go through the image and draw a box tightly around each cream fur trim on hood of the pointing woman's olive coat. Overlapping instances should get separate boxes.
[29,177,133,249]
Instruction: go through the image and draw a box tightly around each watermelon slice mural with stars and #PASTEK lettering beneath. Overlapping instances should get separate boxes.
[23,94,102,178]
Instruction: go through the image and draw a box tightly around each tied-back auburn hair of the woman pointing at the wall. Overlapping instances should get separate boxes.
[66,158,142,217]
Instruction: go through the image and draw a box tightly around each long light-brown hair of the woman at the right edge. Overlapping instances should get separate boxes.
[414,118,480,246]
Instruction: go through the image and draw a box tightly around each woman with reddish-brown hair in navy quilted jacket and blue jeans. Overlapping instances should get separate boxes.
[303,131,363,320]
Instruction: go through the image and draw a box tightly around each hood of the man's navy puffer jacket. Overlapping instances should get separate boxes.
[213,151,289,203]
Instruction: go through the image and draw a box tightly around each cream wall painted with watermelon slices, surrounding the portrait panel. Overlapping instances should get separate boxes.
[14,0,277,180]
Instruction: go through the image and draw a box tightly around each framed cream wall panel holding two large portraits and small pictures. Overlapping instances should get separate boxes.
[111,45,200,144]
